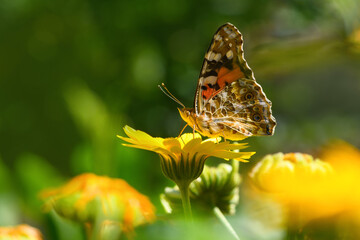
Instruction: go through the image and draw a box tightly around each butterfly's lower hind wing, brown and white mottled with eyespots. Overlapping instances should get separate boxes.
[204,78,276,136]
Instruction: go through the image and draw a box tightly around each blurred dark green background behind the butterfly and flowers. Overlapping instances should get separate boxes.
[0,0,360,239]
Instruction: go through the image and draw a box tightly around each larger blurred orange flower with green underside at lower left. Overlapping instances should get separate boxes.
[41,173,155,232]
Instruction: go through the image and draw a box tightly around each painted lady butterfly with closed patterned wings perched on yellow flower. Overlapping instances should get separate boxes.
[179,23,276,140]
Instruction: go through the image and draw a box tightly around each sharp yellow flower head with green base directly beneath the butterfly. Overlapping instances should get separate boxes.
[118,126,254,184]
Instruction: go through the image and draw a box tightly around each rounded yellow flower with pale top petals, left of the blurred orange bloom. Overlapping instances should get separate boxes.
[250,153,343,221]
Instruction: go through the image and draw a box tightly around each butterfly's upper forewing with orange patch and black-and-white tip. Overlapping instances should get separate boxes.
[195,23,255,114]
